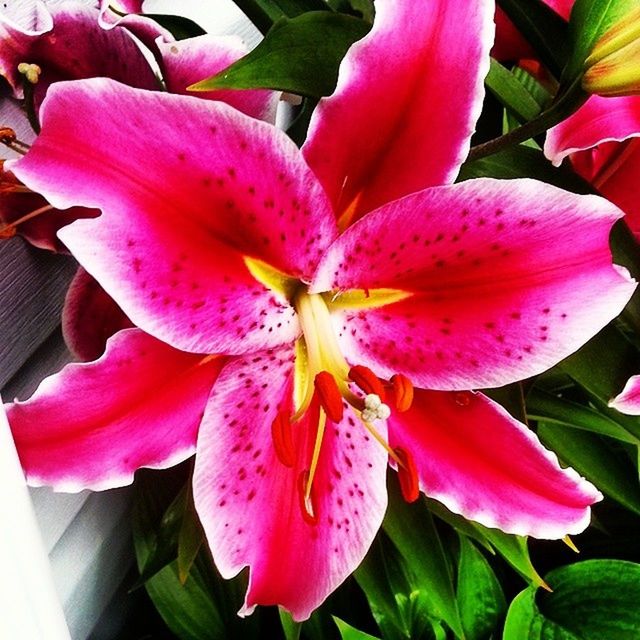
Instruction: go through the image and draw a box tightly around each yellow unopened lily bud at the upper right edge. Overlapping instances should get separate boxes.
[582,7,640,96]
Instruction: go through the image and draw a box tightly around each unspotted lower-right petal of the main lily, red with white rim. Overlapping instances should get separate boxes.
[388,390,602,539]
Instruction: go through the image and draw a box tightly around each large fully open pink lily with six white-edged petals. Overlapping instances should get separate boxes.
[8,0,635,620]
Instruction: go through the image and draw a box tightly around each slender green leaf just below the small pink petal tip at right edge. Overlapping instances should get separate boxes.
[527,388,640,445]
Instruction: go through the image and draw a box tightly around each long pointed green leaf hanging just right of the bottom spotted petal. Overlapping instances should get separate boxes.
[383,488,463,637]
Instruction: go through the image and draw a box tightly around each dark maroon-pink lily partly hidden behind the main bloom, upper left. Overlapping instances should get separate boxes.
[0,1,278,251]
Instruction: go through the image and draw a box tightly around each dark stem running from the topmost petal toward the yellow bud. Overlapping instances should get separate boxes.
[467,77,588,161]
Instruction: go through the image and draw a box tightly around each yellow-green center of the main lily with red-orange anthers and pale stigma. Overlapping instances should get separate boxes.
[245,258,418,524]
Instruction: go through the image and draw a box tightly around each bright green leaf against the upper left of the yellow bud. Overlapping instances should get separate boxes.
[559,0,637,85]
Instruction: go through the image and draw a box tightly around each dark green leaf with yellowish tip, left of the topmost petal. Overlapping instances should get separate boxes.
[189,11,371,97]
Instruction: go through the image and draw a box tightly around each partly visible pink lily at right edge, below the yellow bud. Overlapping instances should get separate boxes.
[544,96,640,238]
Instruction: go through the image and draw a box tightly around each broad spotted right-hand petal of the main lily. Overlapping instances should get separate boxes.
[311,178,636,390]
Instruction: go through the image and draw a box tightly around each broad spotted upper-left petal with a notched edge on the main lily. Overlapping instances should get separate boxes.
[11,79,337,353]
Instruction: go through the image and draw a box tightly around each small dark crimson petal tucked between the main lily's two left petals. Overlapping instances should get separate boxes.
[62,267,133,362]
